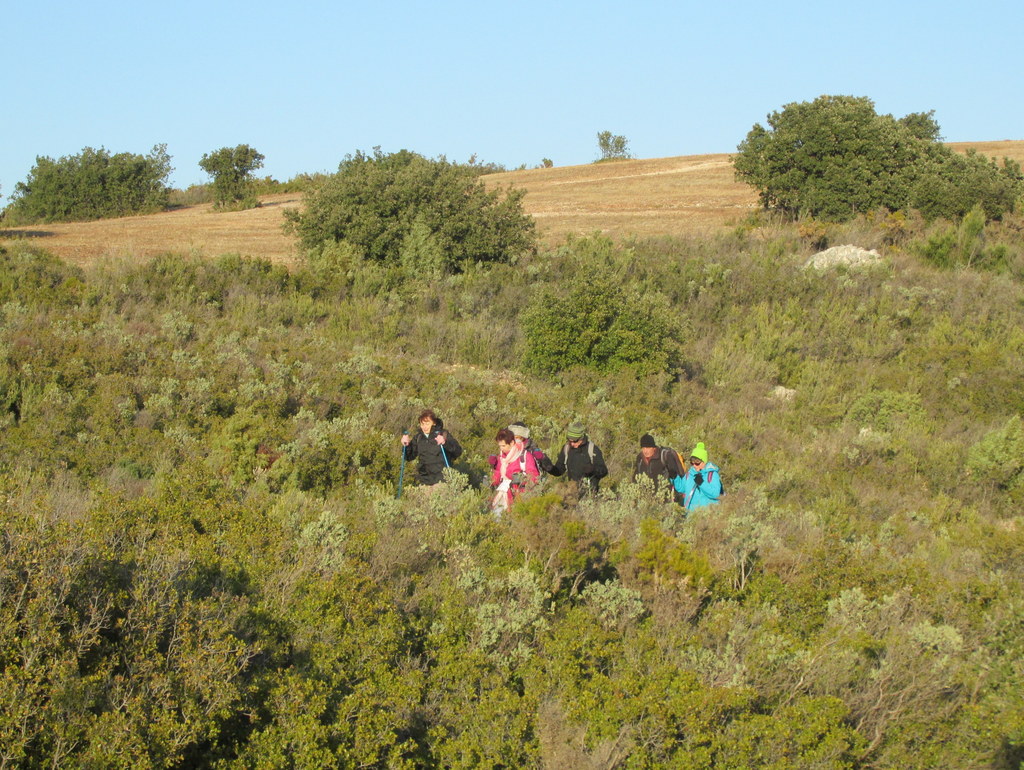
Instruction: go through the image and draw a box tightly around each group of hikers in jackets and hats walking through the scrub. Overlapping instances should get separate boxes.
[398,410,723,515]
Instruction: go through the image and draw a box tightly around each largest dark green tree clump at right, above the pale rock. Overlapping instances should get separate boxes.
[733,96,1024,220]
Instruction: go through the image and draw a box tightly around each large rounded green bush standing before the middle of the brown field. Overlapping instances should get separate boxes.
[289,148,534,275]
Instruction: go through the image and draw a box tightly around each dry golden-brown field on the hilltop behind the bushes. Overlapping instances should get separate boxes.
[0,140,1024,264]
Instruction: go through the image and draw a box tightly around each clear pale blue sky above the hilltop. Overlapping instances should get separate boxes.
[0,0,1024,204]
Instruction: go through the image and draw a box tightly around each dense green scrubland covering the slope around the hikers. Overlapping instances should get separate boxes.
[0,196,1024,768]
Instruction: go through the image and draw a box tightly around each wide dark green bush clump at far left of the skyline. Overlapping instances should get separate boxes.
[4,144,173,224]
